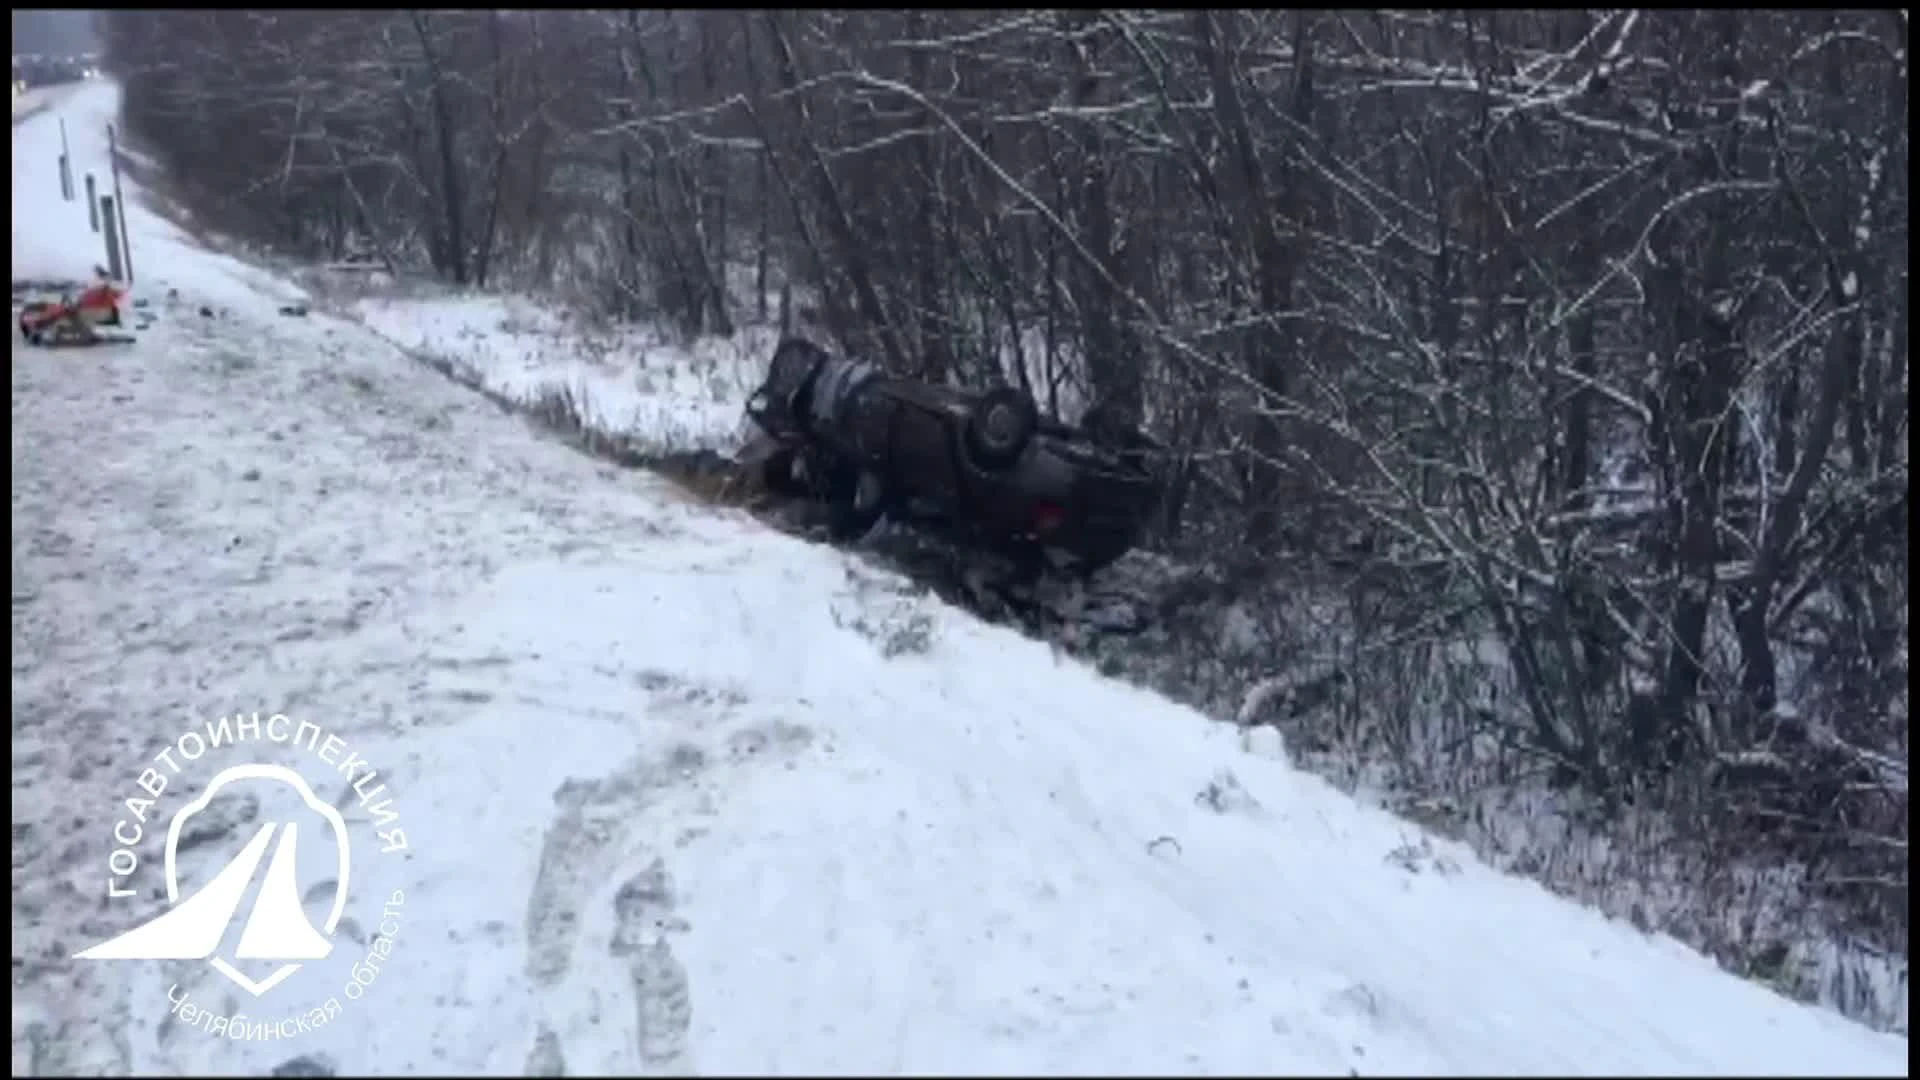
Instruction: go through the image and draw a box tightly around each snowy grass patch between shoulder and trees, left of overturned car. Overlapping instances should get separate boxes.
[348,292,776,454]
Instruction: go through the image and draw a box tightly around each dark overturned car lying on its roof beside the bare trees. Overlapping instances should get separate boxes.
[747,338,1160,575]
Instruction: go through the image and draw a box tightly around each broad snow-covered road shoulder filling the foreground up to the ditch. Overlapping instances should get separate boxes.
[12,79,1908,1076]
